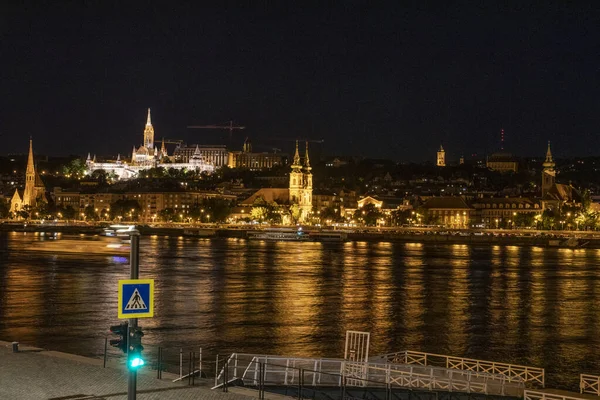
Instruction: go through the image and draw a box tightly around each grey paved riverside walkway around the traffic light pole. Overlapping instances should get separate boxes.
[0,341,258,400]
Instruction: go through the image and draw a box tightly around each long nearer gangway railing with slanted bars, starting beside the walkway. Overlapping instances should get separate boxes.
[213,353,524,397]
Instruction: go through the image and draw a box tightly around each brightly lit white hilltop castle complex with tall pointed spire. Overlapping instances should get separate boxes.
[86,109,215,179]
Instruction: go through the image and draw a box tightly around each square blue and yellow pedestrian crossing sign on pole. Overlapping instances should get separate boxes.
[119,279,154,319]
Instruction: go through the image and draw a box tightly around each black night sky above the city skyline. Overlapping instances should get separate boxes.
[0,1,600,161]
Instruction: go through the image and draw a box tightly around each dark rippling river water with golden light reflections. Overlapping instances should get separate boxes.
[0,233,600,389]
